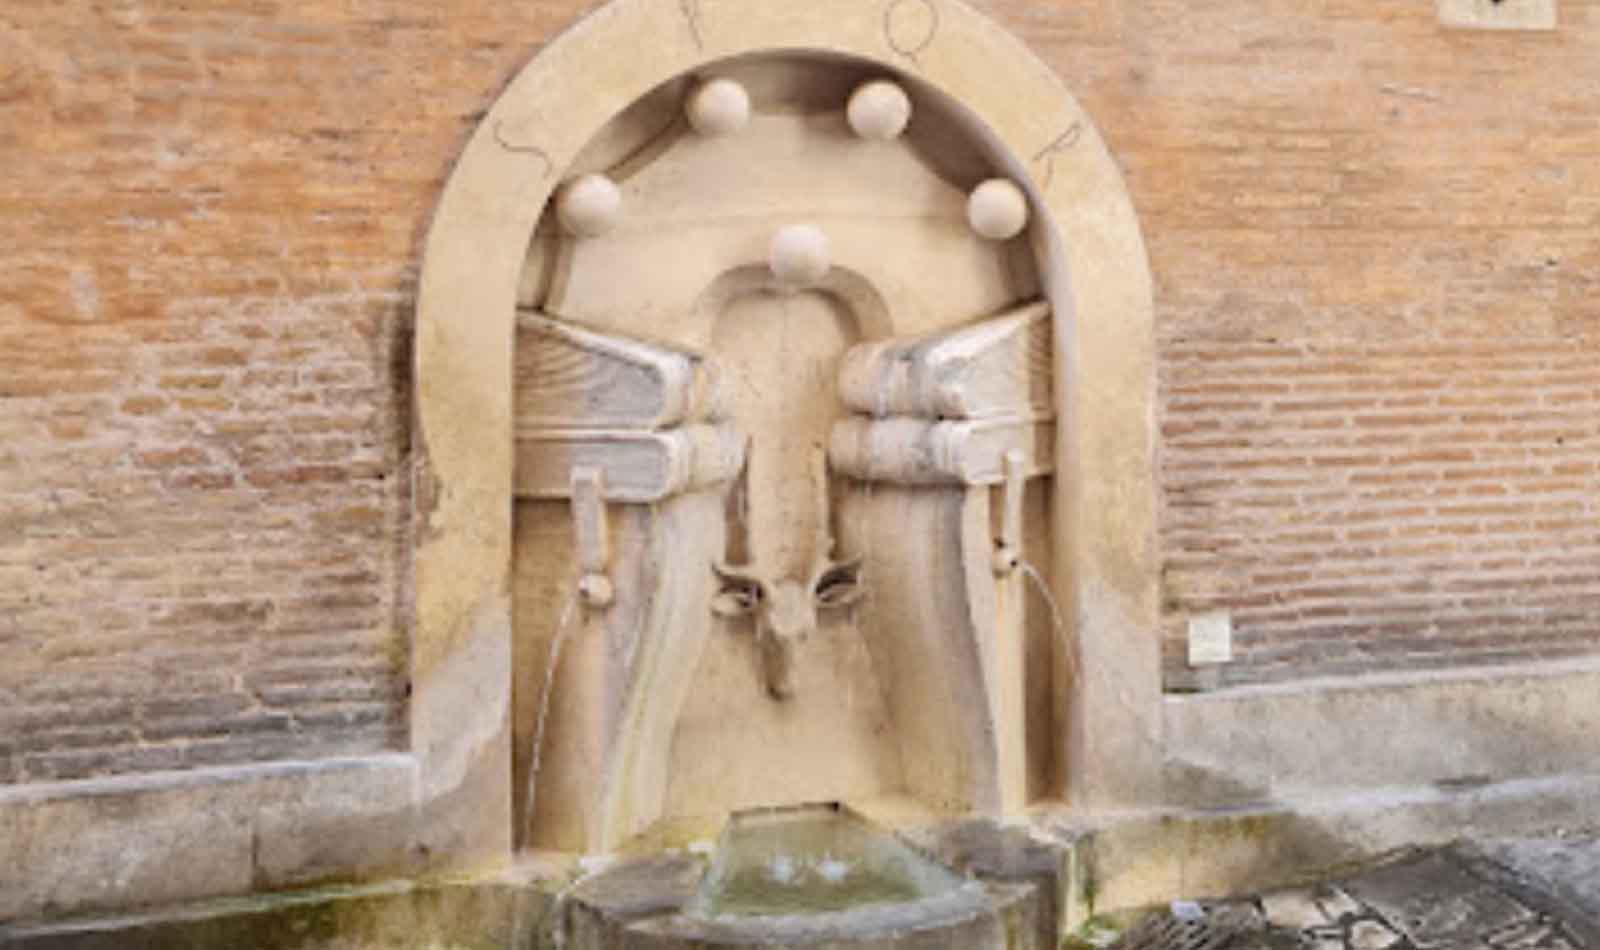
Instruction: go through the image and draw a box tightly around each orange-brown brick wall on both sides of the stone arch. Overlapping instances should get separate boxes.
[0,0,1600,782]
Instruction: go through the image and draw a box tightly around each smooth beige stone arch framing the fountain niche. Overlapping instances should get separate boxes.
[411,0,1160,857]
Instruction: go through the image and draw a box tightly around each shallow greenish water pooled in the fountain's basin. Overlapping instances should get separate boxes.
[686,804,965,918]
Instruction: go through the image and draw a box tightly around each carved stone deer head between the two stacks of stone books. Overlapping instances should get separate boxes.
[712,453,861,699]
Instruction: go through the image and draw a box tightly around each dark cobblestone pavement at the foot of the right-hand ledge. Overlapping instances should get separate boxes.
[1112,835,1600,950]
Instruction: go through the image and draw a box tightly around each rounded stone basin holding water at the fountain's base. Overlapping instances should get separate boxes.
[568,806,1048,950]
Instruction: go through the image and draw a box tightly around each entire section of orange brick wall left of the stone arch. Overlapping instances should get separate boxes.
[0,0,574,782]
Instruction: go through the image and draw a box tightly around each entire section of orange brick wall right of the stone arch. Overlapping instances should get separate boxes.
[1120,0,1600,685]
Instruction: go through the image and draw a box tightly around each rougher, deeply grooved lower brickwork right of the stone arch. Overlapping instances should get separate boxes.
[1162,336,1600,681]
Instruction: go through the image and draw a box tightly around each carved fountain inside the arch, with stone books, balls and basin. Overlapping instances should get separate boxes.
[512,53,1067,947]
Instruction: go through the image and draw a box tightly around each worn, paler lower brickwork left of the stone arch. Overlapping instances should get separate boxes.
[0,293,419,780]
